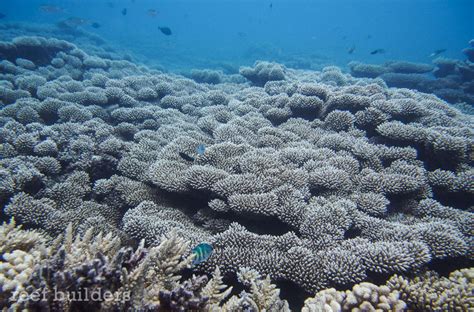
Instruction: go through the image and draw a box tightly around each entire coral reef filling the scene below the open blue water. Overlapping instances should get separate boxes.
[0,33,474,312]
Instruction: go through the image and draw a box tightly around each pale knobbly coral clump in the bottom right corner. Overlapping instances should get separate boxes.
[302,268,474,312]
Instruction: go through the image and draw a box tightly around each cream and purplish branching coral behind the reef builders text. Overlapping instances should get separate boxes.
[0,221,289,311]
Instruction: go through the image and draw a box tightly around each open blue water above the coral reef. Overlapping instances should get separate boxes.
[0,0,474,69]
